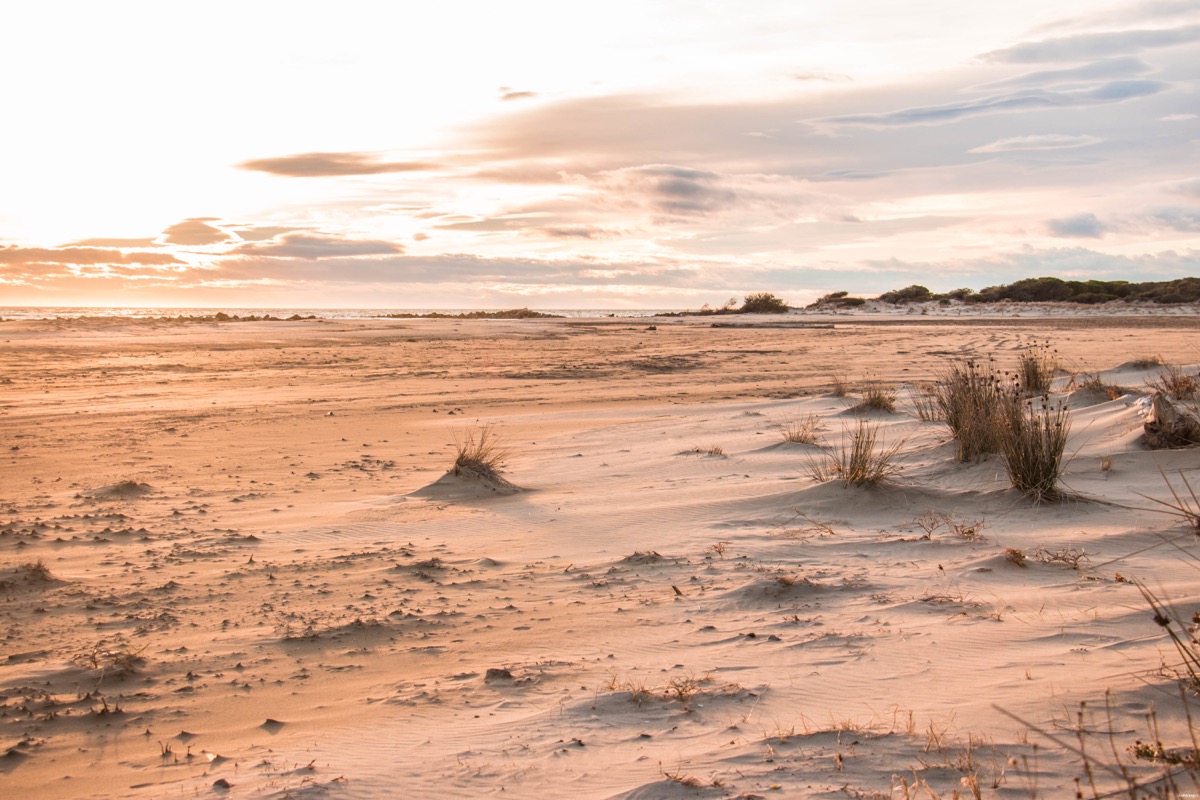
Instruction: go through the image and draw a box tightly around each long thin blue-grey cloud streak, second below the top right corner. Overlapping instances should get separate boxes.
[816,80,1170,127]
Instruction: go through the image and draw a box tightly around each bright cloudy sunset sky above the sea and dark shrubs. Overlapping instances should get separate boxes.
[0,0,1200,309]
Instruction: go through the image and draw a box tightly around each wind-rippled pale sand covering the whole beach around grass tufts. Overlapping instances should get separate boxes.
[0,309,1200,800]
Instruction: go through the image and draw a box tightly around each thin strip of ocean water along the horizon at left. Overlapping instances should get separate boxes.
[0,306,666,319]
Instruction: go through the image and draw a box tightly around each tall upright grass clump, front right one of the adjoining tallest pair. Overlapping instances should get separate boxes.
[1000,397,1070,500]
